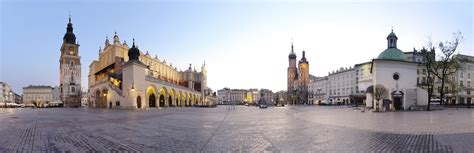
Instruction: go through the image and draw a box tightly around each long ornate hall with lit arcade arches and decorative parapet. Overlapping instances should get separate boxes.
[88,33,213,109]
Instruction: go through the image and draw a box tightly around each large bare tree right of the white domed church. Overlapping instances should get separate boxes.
[426,32,463,106]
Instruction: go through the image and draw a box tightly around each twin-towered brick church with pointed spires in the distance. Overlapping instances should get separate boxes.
[287,43,310,105]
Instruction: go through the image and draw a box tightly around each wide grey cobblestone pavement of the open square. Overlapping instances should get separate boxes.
[0,106,474,152]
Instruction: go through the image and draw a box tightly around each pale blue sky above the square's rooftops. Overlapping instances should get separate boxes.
[0,0,474,93]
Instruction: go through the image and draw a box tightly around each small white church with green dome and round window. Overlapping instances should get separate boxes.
[366,30,427,111]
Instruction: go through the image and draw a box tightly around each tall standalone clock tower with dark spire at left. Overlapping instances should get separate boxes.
[59,16,81,107]
